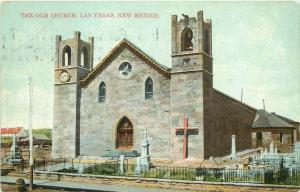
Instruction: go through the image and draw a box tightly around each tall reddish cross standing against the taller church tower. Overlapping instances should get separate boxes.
[176,117,198,159]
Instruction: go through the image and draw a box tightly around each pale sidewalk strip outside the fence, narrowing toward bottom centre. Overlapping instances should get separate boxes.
[1,176,182,192]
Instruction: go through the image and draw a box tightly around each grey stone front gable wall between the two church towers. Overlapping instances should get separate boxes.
[80,48,171,158]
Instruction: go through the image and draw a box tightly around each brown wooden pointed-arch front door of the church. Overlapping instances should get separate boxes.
[116,117,133,149]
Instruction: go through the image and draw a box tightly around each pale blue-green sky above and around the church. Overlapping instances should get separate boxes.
[0,1,300,128]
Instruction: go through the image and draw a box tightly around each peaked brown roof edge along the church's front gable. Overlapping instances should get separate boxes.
[80,39,171,85]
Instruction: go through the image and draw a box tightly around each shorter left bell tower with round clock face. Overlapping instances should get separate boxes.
[52,31,94,157]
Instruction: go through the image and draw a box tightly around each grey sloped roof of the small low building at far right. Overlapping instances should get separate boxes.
[252,109,293,128]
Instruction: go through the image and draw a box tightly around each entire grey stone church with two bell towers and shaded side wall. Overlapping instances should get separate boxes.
[52,11,298,160]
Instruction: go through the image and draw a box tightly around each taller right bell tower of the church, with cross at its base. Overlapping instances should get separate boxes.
[171,11,214,159]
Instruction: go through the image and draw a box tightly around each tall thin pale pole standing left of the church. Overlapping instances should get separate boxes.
[28,77,33,191]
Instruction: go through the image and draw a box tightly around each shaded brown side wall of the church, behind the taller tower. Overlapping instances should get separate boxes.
[213,90,256,156]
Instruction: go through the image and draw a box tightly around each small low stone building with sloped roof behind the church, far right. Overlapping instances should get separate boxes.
[252,109,300,153]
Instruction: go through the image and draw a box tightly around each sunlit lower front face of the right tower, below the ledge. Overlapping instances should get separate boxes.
[171,72,204,160]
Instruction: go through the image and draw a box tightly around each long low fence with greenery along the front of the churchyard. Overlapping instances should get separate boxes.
[34,159,300,185]
